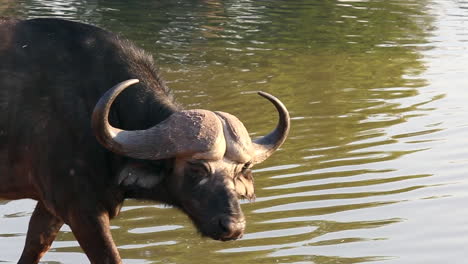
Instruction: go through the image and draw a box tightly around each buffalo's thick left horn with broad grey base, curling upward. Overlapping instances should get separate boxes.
[91,79,222,160]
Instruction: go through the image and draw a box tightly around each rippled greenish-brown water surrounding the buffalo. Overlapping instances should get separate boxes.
[0,0,468,264]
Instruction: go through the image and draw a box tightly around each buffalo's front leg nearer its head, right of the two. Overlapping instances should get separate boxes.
[68,210,122,264]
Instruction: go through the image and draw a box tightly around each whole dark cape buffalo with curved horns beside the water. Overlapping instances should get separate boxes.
[0,18,290,264]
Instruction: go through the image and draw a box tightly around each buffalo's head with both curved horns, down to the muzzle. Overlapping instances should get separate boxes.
[92,80,290,240]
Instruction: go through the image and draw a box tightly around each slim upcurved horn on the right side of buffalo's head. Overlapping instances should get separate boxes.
[252,92,291,164]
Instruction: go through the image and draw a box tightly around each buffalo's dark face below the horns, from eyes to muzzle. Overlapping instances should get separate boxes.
[171,159,254,241]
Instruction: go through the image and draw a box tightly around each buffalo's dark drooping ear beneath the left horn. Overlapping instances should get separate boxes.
[119,162,164,189]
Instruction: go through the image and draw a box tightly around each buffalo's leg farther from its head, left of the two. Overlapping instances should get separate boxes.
[18,201,63,264]
